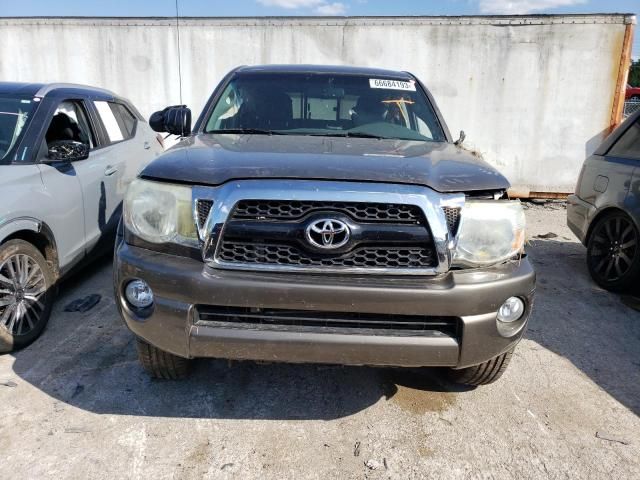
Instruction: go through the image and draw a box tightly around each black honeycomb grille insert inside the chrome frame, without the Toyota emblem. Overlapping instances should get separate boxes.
[216,200,437,272]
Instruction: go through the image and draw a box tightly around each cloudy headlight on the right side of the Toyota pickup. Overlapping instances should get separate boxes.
[453,200,525,266]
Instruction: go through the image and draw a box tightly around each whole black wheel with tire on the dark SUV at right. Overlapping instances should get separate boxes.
[587,212,640,291]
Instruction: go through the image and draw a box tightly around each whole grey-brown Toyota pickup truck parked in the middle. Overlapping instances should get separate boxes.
[114,66,535,385]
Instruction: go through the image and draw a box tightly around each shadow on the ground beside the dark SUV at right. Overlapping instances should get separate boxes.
[526,240,640,415]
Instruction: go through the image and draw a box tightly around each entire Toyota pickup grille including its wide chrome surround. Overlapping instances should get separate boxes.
[192,179,465,276]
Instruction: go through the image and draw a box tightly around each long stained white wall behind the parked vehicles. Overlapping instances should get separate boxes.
[0,15,635,192]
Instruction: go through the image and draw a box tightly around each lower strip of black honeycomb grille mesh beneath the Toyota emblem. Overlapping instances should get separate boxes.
[218,241,435,268]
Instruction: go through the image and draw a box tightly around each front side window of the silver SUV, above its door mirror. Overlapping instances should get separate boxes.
[45,100,96,148]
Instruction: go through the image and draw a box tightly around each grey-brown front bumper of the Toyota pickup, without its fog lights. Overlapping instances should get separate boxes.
[114,238,535,368]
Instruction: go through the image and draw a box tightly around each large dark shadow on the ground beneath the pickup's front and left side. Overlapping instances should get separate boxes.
[5,257,464,420]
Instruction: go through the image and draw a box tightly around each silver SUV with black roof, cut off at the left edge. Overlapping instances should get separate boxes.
[0,82,164,352]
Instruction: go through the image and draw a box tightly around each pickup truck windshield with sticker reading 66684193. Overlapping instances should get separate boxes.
[205,73,445,142]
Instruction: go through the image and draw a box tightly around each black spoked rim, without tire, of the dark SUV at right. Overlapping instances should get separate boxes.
[589,217,638,283]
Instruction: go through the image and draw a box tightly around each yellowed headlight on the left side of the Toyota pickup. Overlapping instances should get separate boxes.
[124,179,197,244]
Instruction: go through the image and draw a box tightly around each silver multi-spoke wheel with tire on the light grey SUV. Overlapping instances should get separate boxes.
[0,240,55,353]
